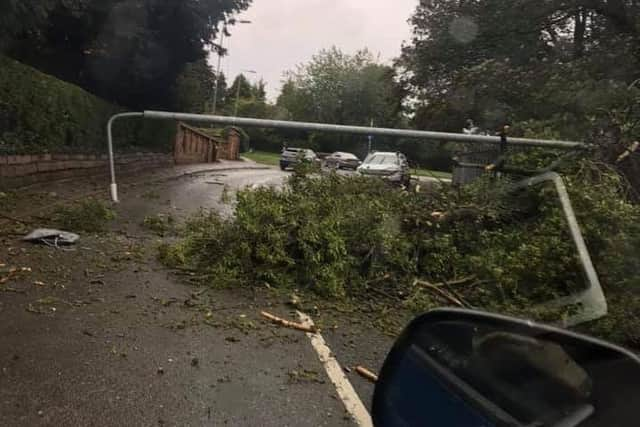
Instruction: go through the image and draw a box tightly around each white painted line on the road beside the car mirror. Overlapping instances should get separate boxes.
[298,311,373,427]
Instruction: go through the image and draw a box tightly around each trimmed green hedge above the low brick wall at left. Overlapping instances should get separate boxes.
[0,55,175,155]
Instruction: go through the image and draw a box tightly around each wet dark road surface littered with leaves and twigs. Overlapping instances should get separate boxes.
[0,162,408,426]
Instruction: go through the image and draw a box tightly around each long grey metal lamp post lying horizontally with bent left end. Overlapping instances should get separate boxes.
[107,111,587,203]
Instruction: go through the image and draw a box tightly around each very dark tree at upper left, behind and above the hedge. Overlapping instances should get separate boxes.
[0,0,251,108]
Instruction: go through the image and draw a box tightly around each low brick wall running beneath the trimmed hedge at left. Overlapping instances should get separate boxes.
[0,153,174,189]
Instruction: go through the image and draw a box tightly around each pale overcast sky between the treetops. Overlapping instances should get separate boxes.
[210,0,418,101]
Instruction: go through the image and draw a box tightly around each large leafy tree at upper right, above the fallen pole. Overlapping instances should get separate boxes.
[397,0,640,137]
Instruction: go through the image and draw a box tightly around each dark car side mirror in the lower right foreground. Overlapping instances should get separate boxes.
[372,309,640,427]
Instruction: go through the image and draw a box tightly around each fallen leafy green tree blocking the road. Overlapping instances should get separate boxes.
[161,159,640,346]
